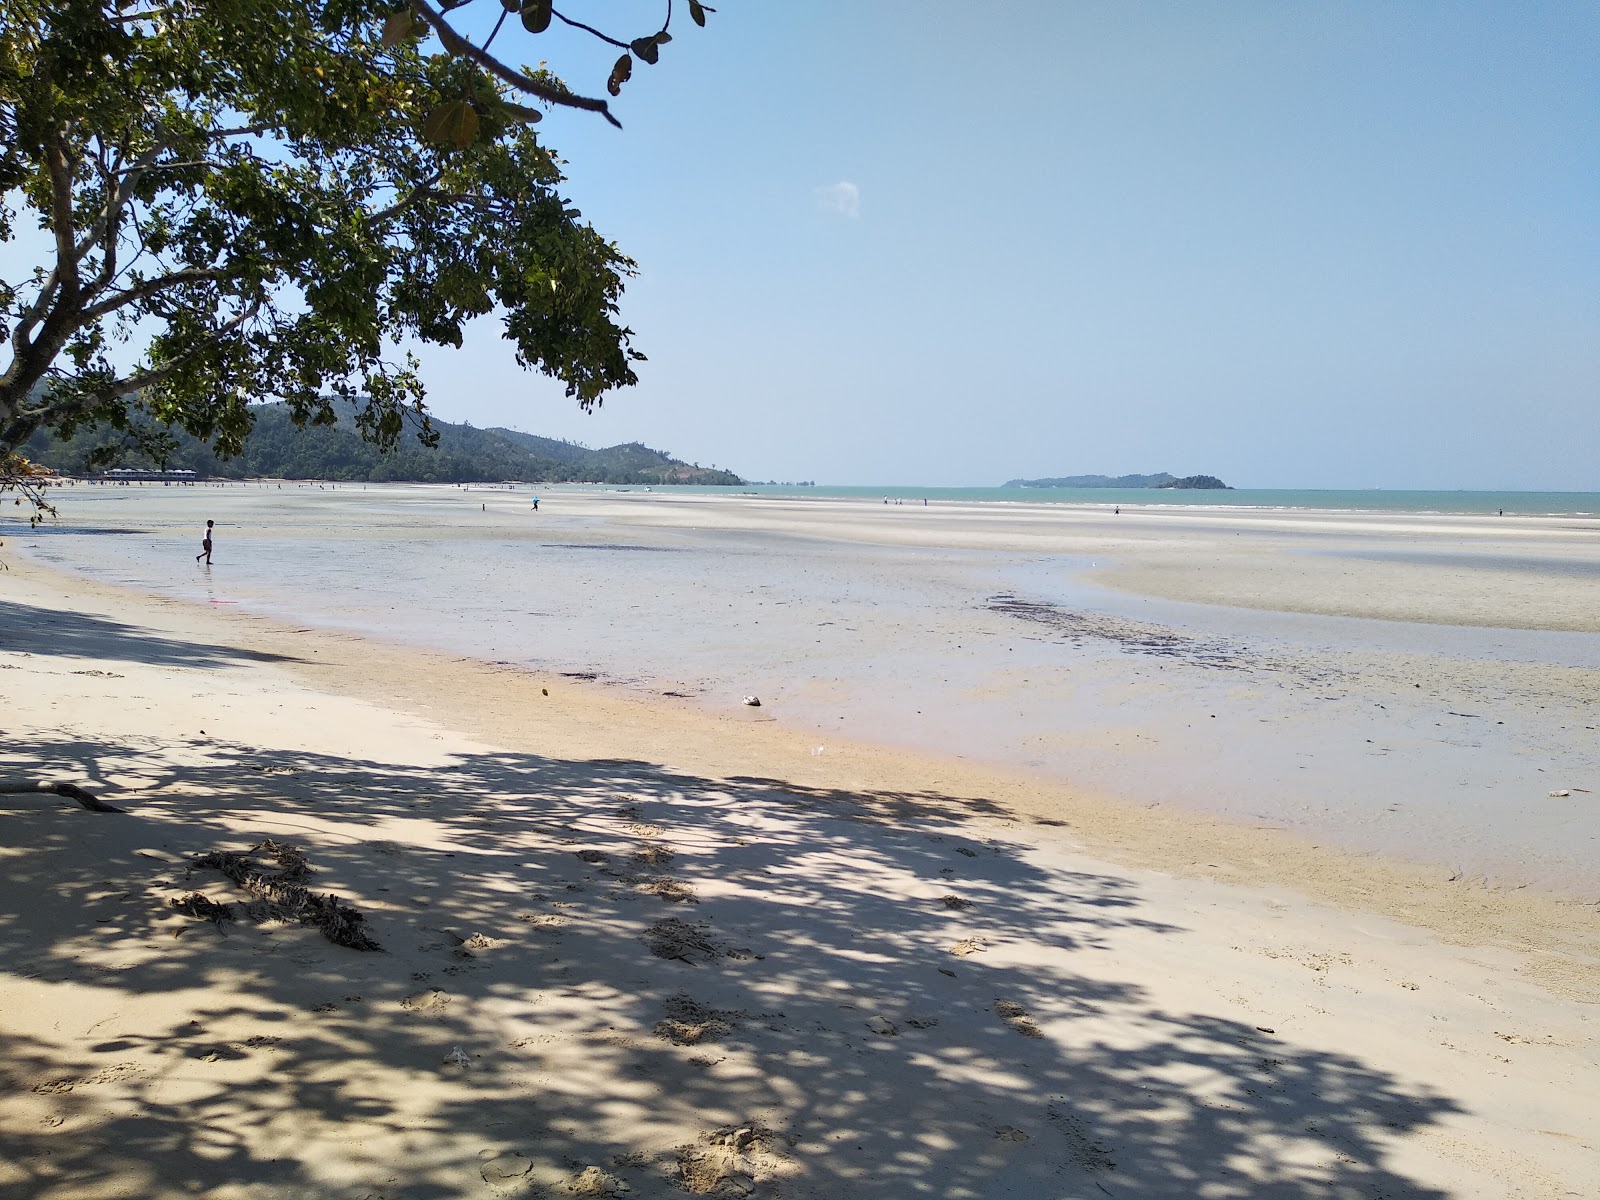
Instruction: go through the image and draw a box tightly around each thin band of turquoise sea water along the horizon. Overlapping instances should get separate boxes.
[595,483,1600,517]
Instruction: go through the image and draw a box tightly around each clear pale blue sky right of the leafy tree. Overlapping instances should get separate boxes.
[426,0,1600,490]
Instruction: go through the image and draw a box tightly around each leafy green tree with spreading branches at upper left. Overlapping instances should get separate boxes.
[0,0,707,490]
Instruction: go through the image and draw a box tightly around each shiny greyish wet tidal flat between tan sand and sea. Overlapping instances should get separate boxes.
[18,488,1600,899]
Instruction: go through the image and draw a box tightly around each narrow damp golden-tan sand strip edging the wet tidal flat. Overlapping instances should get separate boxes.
[3,563,1600,998]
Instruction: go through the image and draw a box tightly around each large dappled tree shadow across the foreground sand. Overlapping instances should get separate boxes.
[0,739,1458,1200]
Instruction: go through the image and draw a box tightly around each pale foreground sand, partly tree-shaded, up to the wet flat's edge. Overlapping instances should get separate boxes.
[0,547,1600,1200]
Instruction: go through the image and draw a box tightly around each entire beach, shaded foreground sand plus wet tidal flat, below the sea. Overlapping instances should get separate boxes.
[0,488,1600,1200]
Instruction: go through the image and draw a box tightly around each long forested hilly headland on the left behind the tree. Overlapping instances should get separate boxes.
[21,403,744,486]
